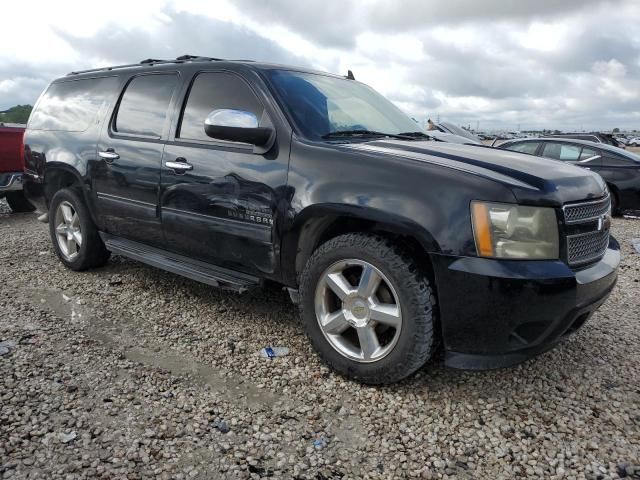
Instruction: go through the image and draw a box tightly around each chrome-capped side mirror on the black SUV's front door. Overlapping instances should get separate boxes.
[204,108,273,147]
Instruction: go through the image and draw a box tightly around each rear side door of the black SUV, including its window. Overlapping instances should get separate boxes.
[92,72,180,245]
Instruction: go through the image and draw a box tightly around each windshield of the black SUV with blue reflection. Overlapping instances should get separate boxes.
[269,70,420,140]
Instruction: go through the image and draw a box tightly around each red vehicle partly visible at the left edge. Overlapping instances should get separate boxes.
[0,123,34,212]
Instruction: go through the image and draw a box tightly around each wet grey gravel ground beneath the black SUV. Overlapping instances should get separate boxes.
[0,197,640,479]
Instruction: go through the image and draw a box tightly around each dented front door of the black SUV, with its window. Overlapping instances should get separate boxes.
[161,72,288,275]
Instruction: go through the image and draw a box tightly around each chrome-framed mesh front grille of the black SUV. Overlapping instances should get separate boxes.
[562,195,611,267]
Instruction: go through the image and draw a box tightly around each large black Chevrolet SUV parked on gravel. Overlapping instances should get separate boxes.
[25,56,620,383]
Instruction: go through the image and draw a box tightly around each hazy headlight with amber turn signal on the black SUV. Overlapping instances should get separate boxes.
[471,201,559,260]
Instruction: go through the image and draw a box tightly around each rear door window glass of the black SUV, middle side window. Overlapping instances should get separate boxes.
[114,75,178,138]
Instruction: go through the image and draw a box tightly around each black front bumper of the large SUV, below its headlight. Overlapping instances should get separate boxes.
[432,237,620,370]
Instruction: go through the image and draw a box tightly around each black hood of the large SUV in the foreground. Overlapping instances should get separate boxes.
[341,140,606,206]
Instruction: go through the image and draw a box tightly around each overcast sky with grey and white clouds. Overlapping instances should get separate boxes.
[0,0,640,130]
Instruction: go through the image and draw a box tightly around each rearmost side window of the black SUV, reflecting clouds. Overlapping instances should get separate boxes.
[29,77,118,132]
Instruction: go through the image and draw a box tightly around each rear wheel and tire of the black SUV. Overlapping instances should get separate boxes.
[49,188,110,271]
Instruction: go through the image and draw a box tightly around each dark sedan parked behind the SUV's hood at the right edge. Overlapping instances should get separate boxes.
[498,136,640,215]
